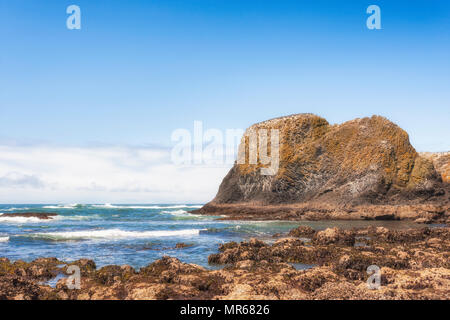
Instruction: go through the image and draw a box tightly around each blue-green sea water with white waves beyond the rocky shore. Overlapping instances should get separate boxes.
[0,204,419,268]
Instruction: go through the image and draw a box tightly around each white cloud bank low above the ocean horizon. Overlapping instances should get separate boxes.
[0,145,230,203]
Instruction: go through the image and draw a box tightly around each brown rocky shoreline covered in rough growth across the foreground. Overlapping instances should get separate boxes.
[0,226,450,300]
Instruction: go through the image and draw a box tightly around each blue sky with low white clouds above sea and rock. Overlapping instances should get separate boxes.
[0,0,450,203]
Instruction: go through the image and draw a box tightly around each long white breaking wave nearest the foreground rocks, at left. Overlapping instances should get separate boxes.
[24,229,203,240]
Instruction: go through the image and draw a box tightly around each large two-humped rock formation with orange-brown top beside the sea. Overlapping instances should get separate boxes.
[200,114,448,222]
